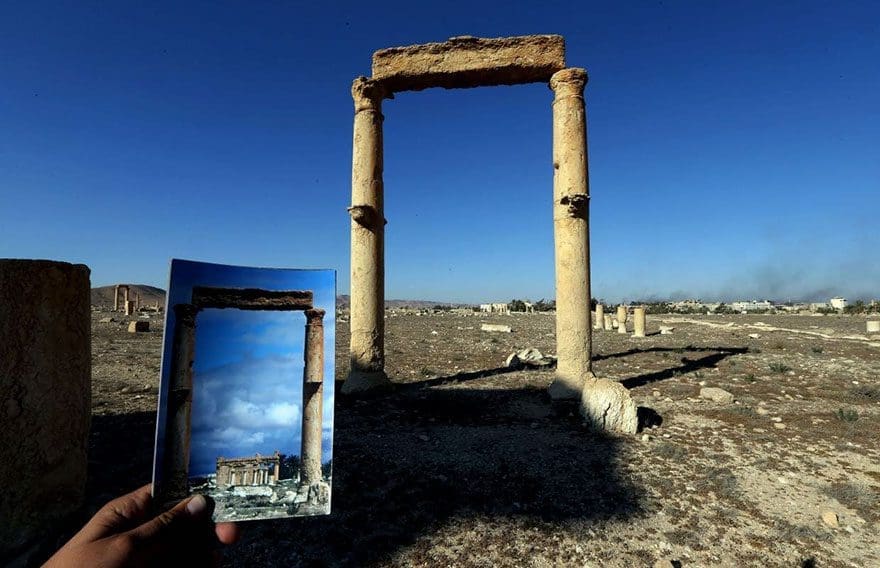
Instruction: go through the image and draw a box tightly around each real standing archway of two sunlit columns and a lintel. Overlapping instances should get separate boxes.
[342,35,592,398]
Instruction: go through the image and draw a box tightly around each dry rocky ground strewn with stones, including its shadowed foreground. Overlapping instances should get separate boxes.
[79,312,880,567]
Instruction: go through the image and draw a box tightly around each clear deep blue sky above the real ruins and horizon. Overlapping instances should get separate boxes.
[0,0,880,302]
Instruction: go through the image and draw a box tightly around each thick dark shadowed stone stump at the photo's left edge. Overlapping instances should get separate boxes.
[0,259,92,566]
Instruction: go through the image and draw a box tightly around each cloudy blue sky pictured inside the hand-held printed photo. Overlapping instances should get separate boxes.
[151,260,336,475]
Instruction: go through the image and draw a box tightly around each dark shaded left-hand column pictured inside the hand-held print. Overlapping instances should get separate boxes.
[156,304,198,505]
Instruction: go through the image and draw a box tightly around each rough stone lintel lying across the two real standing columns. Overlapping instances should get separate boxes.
[372,35,565,92]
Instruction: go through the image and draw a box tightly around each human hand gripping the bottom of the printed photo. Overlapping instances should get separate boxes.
[44,485,239,568]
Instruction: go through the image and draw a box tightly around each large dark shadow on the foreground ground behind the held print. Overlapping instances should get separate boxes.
[81,387,643,566]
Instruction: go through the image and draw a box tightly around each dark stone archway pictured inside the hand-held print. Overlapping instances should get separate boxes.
[156,286,324,503]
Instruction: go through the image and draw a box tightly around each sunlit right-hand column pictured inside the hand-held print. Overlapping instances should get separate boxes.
[300,309,324,485]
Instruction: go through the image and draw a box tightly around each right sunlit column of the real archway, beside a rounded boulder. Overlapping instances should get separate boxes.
[550,68,593,399]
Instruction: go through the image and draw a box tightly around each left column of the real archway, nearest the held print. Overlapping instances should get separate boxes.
[342,77,388,393]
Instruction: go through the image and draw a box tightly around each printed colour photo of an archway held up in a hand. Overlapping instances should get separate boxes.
[153,259,336,522]
